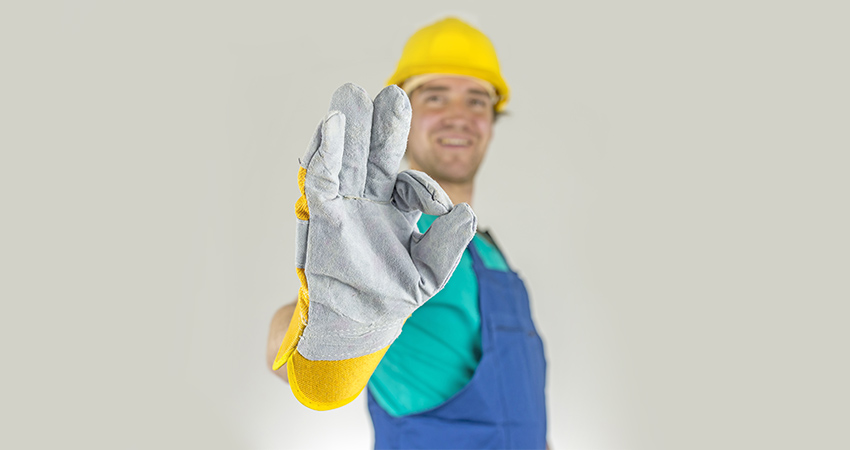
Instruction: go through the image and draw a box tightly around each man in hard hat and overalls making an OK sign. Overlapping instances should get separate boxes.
[269,18,546,448]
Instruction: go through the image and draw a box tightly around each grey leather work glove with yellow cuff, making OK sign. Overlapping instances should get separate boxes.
[274,84,476,410]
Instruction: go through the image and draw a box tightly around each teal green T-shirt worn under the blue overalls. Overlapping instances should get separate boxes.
[369,214,508,417]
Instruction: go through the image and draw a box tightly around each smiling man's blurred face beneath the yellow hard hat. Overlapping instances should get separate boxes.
[407,77,493,183]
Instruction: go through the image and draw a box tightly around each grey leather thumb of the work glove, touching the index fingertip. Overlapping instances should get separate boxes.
[410,203,478,298]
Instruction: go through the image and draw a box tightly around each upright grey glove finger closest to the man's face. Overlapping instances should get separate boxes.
[364,85,411,201]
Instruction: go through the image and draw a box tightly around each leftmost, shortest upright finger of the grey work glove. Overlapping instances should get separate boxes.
[301,111,346,203]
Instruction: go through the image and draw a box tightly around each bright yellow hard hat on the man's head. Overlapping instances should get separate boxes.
[387,17,510,111]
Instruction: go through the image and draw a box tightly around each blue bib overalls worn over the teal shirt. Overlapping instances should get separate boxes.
[368,244,546,449]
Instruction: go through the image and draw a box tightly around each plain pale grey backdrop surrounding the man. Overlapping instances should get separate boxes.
[0,0,850,450]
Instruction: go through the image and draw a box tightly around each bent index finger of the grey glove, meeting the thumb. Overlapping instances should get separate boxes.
[393,170,452,216]
